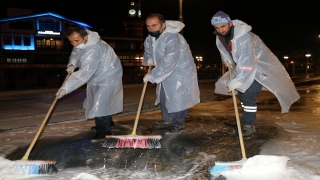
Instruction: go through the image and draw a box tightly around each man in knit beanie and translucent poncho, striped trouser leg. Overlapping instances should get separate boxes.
[211,11,300,137]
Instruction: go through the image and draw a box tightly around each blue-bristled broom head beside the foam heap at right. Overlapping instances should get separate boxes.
[210,158,247,176]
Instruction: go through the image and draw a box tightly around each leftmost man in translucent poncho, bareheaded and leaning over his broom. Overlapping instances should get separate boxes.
[57,27,123,141]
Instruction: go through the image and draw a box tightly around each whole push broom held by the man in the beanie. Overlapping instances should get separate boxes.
[210,63,247,176]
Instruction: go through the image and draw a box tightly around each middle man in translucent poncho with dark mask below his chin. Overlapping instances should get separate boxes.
[142,14,200,132]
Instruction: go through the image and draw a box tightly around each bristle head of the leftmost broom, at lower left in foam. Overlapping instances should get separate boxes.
[14,160,58,174]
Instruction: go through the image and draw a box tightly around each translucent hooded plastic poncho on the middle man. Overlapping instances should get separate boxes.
[142,21,200,113]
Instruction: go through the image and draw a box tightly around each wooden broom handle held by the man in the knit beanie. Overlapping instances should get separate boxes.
[228,62,247,158]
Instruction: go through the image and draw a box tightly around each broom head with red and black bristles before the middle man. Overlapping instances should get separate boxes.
[102,135,161,149]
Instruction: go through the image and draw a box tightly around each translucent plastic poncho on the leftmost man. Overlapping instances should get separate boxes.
[62,30,123,119]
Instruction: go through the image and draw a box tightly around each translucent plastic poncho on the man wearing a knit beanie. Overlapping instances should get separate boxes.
[215,20,300,113]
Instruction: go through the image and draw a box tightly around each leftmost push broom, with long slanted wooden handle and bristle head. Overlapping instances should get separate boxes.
[14,73,70,174]
